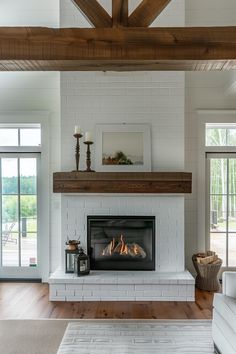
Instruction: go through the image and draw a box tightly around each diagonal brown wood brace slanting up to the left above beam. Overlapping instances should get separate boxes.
[72,0,112,28]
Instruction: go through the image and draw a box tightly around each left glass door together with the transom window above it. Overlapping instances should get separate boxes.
[0,124,41,277]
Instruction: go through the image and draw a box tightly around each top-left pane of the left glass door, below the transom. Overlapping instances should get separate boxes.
[2,158,18,194]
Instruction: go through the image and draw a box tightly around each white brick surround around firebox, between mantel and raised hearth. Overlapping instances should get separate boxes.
[62,194,184,272]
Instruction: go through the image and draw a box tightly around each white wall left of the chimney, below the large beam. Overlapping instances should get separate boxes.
[0,72,61,269]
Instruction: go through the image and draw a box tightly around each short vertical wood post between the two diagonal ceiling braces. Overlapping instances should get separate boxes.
[112,0,129,27]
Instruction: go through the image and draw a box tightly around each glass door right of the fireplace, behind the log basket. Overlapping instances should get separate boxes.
[207,153,236,268]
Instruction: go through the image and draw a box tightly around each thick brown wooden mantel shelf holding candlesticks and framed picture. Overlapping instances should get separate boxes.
[53,172,192,194]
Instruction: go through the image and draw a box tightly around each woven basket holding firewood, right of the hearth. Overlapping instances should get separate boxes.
[192,254,222,291]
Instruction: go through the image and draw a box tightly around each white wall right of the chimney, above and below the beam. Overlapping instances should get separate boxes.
[185,0,236,269]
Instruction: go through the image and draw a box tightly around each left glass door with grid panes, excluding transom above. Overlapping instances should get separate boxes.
[0,153,40,278]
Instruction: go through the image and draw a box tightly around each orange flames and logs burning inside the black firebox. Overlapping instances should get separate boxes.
[102,235,147,258]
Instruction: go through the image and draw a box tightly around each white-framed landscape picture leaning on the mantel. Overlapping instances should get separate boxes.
[95,124,151,172]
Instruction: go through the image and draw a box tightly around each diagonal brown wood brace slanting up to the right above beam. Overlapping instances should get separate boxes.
[128,0,171,27]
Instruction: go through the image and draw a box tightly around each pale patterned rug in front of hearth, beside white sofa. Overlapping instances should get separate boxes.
[58,320,214,354]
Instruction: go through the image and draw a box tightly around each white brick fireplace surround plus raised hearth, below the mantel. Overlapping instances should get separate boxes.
[50,194,194,301]
